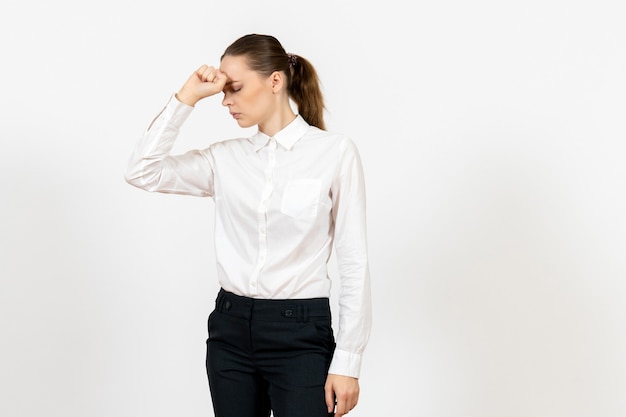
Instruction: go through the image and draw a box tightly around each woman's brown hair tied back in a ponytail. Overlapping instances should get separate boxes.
[222,34,326,129]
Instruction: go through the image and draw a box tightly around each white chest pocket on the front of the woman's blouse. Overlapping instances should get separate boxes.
[280,179,322,219]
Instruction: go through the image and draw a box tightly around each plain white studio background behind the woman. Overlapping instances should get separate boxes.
[0,0,626,417]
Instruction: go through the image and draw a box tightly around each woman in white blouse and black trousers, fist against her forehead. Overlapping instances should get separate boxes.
[126,34,371,417]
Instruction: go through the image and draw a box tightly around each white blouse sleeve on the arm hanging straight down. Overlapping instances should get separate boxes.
[329,140,372,377]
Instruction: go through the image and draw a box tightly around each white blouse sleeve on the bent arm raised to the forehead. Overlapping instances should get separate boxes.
[125,96,214,197]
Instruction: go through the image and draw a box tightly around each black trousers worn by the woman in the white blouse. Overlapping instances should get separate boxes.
[206,289,335,417]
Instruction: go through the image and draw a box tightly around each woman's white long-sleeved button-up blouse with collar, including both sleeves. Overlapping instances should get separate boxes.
[126,96,371,377]
